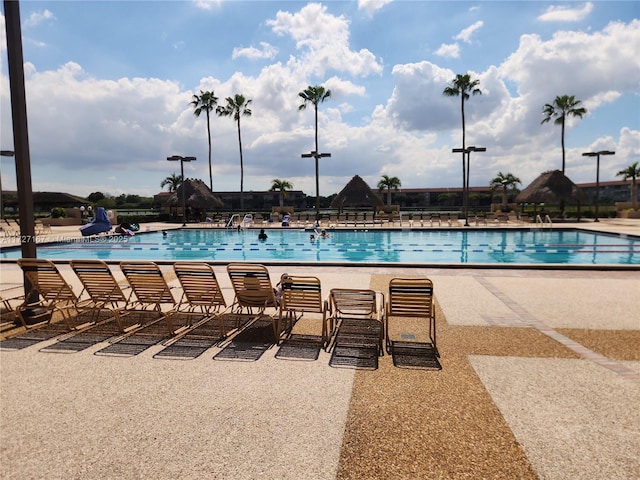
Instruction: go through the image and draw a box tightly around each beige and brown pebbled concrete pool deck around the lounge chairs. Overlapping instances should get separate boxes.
[0,219,640,480]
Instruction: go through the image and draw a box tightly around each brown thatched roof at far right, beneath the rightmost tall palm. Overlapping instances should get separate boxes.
[516,170,586,203]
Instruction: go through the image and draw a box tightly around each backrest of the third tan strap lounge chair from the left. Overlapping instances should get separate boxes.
[120,262,175,311]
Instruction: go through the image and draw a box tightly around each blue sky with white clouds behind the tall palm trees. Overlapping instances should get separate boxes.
[0,0,640,196]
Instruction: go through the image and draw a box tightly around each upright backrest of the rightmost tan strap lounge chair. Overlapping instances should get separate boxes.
[387,278,433,317]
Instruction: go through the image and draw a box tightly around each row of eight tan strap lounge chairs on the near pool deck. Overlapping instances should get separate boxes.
[2,259,439,361]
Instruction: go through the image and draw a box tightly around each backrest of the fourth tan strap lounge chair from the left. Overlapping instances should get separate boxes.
[173,262,227,307]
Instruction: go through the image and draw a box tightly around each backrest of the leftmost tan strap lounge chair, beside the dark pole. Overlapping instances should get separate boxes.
[18,258,78,303]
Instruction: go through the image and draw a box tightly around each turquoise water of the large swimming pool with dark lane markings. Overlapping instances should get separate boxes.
[0,229,640,265]
